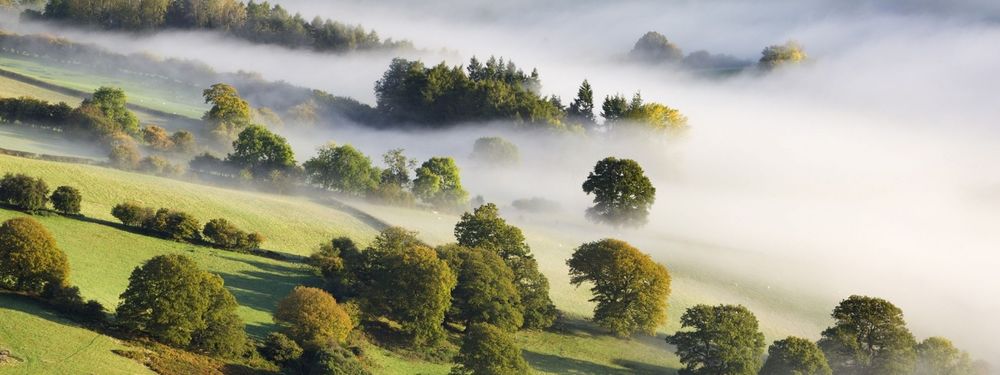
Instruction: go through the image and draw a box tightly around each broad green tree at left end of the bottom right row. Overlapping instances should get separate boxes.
[667,305,766,375]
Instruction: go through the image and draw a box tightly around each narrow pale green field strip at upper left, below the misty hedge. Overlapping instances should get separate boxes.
[0,54,208,119]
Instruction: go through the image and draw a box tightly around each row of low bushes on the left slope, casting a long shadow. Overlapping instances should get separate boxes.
[111,202,264,251]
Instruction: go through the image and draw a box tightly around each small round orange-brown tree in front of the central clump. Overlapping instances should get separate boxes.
[274,286,354,348]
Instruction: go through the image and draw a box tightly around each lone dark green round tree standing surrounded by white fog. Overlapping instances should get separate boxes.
[583,157,656,226]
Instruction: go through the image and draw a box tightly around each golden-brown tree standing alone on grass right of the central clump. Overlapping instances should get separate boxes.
[566,239,670,336]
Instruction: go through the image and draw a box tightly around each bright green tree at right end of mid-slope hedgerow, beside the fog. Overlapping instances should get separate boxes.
[413,157,469,208]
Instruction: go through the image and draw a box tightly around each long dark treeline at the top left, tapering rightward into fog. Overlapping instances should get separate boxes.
[24,0,412,52]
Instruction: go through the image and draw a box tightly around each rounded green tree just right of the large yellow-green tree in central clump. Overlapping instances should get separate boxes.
[437,245,524,331]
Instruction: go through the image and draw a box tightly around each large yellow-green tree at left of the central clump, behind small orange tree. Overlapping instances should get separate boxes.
[359,228,456,347]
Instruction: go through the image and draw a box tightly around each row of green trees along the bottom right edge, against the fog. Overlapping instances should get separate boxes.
[667,296,983,375]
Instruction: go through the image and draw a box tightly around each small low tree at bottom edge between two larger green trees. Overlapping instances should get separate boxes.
[760,337,833,375]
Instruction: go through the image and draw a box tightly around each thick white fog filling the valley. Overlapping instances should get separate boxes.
[1,0,1000,362]
